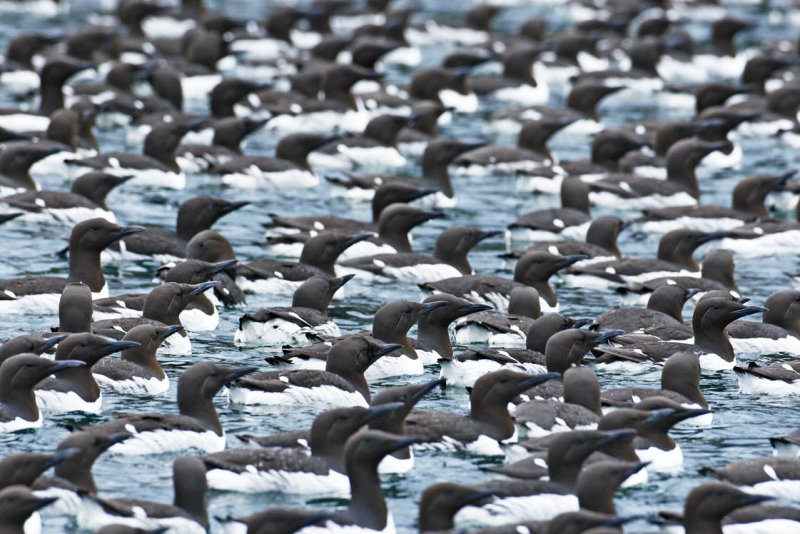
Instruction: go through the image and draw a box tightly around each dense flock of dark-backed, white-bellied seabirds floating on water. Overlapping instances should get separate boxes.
[0,0,800,534]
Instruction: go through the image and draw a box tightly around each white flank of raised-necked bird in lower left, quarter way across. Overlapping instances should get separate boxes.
[108,425,225,456]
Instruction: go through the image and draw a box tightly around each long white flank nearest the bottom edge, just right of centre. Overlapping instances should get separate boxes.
[455,493,578,526]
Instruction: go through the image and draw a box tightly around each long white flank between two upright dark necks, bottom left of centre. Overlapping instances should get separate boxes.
[206,465,350,495]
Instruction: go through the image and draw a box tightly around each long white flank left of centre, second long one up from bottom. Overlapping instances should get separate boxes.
[223,385,369,408]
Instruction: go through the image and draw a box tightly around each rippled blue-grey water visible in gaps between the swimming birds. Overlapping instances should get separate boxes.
[0,0,800,532]
